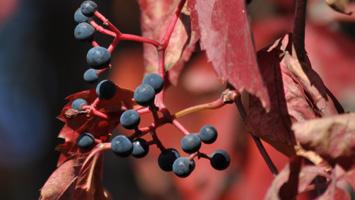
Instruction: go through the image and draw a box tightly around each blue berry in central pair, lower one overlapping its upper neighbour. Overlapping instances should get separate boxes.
[133,84,155,106]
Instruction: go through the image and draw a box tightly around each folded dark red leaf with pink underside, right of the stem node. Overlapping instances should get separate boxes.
[247,35,338,155]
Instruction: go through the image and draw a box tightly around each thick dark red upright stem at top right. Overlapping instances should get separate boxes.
[292,0,307,61]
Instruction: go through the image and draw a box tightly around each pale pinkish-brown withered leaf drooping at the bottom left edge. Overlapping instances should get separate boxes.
[40,154,111,200]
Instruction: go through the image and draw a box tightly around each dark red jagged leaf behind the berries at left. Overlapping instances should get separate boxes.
[56,88,133,166]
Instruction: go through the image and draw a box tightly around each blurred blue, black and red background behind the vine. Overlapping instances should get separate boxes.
[0,0,355,200]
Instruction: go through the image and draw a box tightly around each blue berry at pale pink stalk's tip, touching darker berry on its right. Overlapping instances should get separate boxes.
[111,135,133,157]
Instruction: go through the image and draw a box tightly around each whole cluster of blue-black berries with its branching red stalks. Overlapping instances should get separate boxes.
[71,1,235,177]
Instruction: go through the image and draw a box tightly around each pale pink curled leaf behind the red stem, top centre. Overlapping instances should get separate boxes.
[139,0,198,84]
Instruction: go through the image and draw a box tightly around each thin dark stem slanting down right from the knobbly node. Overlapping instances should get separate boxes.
[235,95,279,176]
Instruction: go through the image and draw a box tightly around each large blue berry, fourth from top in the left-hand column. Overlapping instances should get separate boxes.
[86,46,111,69]
